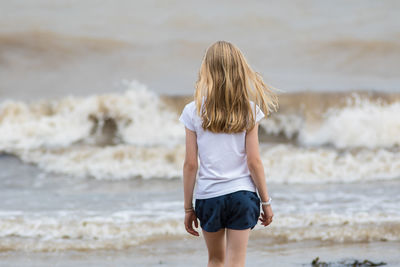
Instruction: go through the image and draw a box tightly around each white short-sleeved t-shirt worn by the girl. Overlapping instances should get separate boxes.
[179,101,264,199]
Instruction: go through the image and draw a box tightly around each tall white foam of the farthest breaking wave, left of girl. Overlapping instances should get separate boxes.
[0,81,184,153]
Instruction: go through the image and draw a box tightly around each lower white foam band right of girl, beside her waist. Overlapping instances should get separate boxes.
[260,144,400,183]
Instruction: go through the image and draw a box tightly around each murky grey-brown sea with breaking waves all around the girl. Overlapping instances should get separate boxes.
[0,0,400,266]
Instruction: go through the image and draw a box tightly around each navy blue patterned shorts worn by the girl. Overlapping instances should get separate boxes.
[195,190,260,232]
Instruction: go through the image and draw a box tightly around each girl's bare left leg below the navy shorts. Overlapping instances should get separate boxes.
[203,228,225,267]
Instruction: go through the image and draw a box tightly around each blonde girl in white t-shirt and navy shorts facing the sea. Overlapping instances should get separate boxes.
[179,41,278,267]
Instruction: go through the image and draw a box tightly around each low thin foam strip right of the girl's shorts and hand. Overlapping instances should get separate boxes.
[255,212,400,243]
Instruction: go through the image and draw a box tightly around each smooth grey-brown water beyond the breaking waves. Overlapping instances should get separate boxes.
[0,0,400,99]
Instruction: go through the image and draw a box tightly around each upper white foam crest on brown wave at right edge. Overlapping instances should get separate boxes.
[299,94,400,148]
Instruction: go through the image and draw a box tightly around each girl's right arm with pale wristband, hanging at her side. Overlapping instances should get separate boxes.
[246,123,274,226]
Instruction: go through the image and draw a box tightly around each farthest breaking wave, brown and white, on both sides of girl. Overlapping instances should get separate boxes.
[0,84,400,153]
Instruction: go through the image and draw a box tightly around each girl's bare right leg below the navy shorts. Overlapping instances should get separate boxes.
[226,229,250,267]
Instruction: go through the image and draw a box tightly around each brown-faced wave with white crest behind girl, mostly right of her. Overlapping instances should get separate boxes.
[164,91,400,149]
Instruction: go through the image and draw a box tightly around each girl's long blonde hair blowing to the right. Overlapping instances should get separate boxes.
[194,41,278,133]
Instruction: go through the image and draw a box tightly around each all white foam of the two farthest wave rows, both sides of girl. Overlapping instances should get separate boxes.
[0,84,400,183]
